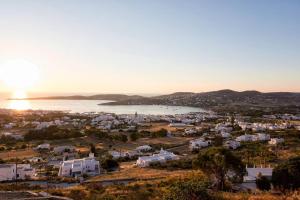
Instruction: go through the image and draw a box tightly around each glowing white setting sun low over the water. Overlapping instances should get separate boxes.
[0,60,40,98]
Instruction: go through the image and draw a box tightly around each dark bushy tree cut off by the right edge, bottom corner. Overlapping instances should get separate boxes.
[272,157,300,190]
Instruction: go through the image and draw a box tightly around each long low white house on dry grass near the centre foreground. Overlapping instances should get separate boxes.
[136,149,179,167]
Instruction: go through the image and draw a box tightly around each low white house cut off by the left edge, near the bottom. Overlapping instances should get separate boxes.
[0,164,35,181]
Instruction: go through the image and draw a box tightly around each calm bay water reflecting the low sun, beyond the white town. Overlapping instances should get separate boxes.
[0,92,205,115]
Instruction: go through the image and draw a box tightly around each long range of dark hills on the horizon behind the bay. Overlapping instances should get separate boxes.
[15,89,300,111]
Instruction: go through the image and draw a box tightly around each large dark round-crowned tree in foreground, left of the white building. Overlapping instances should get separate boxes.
[193,147,245,190]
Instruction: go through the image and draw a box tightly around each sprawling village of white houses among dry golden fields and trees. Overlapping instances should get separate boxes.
[0,109,300,199]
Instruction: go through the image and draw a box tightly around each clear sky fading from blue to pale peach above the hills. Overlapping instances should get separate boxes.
[0,0,300,94]
